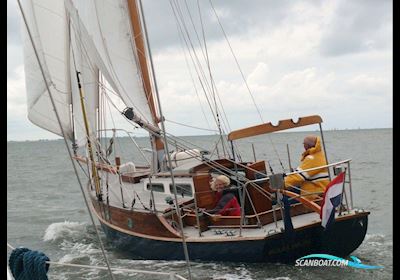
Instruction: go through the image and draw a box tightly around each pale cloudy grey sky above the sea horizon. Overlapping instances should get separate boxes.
[7,0,393,141]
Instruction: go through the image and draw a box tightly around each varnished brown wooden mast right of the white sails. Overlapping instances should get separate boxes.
[127,0,165,172]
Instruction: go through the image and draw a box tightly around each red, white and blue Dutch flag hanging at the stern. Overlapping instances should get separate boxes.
[320,172,345,228]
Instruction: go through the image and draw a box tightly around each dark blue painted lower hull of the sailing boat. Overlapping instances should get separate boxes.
[100,213,368,263]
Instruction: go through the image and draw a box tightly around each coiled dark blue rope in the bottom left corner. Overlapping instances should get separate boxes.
[8,247,50,280]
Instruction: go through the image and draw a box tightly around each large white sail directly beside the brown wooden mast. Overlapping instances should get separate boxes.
[69,0,152,123]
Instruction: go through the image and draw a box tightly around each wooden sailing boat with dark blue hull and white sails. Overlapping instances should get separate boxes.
[19,0,369,262]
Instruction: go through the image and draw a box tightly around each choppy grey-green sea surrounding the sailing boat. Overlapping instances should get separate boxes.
[7,129,393,280]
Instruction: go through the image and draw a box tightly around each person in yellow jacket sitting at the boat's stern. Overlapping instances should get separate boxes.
[285,135,330,200]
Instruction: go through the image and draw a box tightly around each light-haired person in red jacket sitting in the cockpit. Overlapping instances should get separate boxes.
[207,175,241,216]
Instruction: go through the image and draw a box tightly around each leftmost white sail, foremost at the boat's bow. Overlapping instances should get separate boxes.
[22,0,73,139]
